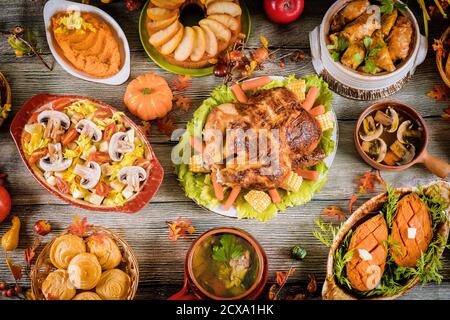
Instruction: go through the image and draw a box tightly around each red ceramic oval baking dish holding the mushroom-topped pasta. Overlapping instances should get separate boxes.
[10,94,164,213]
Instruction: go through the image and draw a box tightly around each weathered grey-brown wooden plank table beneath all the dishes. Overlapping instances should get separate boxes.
[0,0,450,299]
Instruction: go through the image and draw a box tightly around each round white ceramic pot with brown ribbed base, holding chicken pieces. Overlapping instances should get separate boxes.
[309,0,428,100]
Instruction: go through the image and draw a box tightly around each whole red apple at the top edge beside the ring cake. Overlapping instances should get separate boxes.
[264,0,305,24]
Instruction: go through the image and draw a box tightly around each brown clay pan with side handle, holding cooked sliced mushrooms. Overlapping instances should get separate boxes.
[354,100,450,178]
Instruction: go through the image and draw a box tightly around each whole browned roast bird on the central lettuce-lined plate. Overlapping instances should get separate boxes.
[203,88,325,190]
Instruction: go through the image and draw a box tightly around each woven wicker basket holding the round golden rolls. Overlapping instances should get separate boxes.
[30,226,139,300]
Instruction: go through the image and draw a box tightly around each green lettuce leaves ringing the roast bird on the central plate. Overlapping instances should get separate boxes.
[172,75,337,221]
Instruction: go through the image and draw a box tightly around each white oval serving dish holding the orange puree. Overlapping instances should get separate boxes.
[44,0,130,85]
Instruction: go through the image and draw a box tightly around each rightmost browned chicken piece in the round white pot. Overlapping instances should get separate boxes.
[387,16,413,62]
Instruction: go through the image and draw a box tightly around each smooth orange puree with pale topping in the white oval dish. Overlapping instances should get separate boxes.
[51,11,121,78]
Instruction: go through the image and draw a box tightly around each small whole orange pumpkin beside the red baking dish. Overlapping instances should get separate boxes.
[123,73,173,121]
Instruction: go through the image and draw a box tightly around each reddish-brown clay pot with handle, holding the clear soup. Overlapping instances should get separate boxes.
[168,228,269,300]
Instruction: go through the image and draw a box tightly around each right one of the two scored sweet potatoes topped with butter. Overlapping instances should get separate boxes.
[391,192,433,267]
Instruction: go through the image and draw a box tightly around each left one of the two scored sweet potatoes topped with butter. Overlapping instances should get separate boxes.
[346,214,388,291]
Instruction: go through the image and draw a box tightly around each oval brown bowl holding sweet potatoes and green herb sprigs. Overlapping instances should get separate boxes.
[322,181,450,300]
